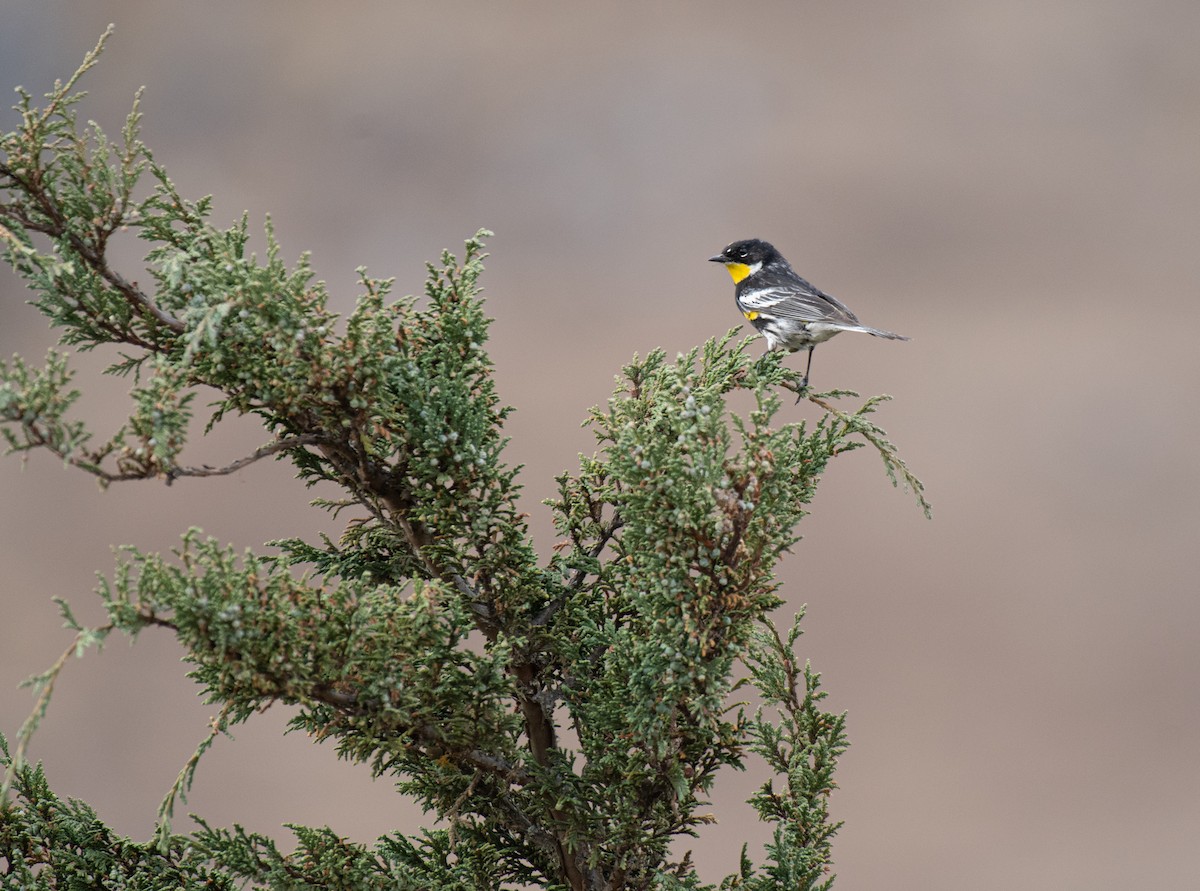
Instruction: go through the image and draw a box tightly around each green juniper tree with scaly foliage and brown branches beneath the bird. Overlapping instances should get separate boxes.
[0,29,928,890]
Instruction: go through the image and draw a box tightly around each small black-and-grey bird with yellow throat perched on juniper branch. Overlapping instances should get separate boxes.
[709,238,908,388]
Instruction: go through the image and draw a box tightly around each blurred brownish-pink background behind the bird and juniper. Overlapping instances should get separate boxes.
[0,0,1200,891]
